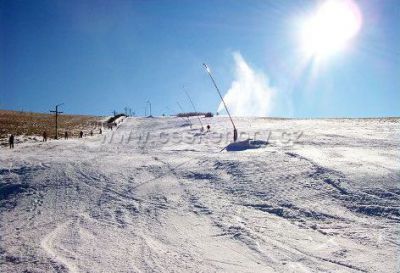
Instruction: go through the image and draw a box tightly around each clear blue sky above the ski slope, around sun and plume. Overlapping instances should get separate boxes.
[0,0,400,117]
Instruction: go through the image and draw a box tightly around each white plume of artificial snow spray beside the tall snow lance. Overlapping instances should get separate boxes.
[218,52,276,116]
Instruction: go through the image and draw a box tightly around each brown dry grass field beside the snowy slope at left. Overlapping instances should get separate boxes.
[0,110,101,139]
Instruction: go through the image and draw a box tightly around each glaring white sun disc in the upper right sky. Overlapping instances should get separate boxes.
[300,0,362,57]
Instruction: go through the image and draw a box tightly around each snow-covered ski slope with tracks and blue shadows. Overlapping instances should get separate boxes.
[0,117,400,273]
